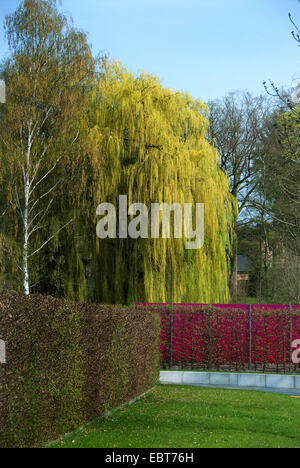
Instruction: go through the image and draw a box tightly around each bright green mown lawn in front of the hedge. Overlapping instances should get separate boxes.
[48,385,300,448]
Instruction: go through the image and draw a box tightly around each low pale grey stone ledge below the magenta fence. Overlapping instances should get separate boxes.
[160,371,300,394]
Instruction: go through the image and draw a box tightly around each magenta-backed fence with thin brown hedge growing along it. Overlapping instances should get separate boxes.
[136,304,300,372]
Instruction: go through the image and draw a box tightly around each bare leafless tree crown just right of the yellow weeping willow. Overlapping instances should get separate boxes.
[209,92,268,214]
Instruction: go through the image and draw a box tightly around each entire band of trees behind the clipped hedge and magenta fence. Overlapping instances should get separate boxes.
[0,0,300,304]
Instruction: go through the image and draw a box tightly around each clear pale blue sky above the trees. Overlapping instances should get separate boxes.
[0,0,300,101]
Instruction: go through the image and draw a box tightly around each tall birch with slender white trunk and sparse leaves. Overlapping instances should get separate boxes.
[0,0,93,295]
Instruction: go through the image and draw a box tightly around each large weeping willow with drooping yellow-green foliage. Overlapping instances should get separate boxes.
[90,61,236,303]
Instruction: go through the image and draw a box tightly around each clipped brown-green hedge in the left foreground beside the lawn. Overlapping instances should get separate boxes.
[0,292,160,448]
